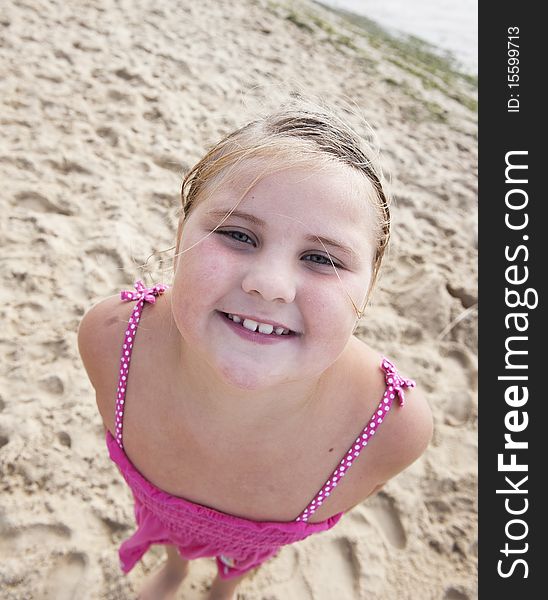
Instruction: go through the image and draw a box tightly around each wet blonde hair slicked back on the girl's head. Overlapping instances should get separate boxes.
[181,103,390,318]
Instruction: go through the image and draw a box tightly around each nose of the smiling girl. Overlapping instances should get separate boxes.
[242,260,297,303]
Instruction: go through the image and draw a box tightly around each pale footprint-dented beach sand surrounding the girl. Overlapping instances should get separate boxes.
[0,0,477,600]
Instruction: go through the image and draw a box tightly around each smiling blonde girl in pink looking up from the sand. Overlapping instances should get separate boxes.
[78,107,432,600]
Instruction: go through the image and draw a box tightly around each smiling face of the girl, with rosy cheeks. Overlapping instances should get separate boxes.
[172,165,376,390]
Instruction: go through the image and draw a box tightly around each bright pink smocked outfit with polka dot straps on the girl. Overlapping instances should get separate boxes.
[106,281,415,579]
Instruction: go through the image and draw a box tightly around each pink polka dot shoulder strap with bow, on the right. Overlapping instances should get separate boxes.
[296,358,415,521]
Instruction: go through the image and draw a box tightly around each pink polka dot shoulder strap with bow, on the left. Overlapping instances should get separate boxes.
[115,281,167,450]
